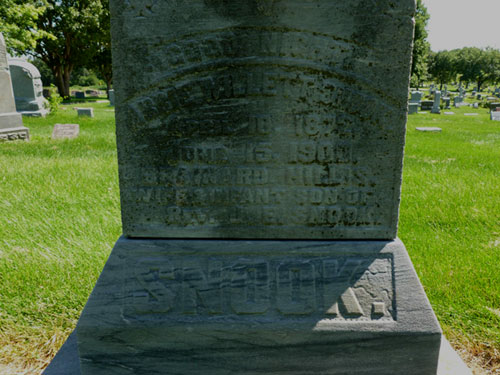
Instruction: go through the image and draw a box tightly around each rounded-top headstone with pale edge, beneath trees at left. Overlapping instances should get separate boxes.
[9,59,49,116]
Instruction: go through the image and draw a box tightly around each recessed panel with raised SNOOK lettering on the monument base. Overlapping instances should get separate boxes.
[124,256,395,321]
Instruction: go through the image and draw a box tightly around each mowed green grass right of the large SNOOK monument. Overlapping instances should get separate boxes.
[399,107,500,373]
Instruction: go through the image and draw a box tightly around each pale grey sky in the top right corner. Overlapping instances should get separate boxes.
[423,0,500,52]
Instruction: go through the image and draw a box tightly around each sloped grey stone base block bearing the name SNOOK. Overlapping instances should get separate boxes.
[61,238,441,375]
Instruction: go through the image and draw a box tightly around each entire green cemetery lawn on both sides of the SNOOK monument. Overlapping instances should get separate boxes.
[0,103,500,374]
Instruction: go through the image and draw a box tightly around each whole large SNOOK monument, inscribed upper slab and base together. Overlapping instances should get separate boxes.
[55,0,441,375]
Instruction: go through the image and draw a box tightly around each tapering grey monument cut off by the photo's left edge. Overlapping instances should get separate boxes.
[0,33,29,141]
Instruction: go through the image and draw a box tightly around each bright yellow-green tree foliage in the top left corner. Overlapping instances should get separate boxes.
[0,0,50,53]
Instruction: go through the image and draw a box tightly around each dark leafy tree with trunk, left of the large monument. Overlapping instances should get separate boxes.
[21,0,109,98]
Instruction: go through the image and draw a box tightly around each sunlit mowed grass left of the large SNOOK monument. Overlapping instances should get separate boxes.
[0,103,121,374]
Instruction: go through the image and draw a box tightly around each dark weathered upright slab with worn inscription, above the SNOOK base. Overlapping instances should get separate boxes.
[111,0,415,239]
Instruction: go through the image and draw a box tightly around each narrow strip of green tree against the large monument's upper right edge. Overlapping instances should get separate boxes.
[411,0,430,88]
